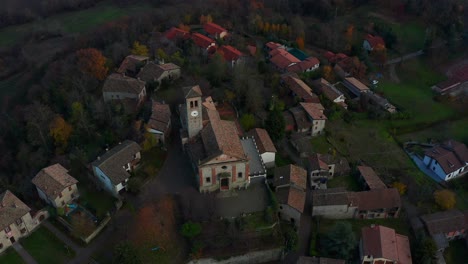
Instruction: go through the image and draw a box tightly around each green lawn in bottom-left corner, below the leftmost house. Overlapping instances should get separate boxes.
[21,227,75,264]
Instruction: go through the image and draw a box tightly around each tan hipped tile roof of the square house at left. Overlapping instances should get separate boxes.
[32,163,78,200]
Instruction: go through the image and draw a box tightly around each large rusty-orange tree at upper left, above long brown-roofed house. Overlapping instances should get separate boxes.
[76,48,108,80]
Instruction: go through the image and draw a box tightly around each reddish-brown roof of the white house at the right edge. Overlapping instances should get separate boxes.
[425,140,468,174]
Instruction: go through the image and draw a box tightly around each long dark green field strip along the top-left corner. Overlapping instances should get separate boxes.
[0,2,150,46]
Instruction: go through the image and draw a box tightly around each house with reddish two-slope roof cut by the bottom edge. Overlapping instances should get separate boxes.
[359,225,413,264]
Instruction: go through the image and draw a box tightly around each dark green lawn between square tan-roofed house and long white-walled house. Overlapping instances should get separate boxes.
[78,184,115,219]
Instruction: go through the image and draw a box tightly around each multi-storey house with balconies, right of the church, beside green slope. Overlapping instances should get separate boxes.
[308,153,350,188]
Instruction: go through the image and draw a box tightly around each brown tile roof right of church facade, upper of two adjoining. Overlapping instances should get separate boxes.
[273,164,307,190]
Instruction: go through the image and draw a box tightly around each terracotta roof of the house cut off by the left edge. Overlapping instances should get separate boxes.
[0,190,31,230]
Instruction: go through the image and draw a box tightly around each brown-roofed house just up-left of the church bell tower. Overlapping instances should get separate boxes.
[137,62,180,84]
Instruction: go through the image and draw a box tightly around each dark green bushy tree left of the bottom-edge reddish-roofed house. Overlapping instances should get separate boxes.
[320,222,356,259]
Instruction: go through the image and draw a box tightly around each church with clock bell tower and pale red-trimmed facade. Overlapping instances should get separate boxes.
[179,85,250,192]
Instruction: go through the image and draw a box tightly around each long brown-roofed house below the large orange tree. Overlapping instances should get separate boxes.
[102,73,146,111]
